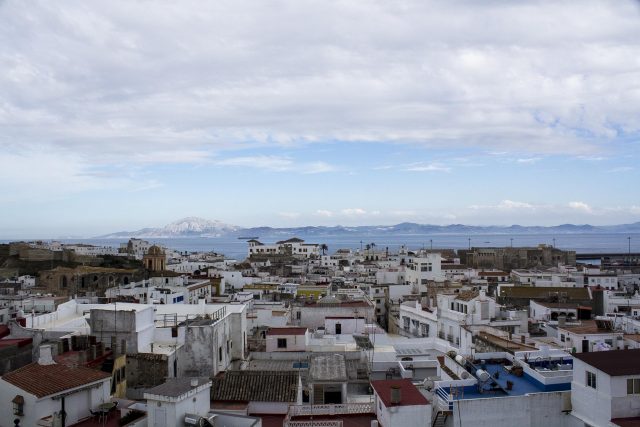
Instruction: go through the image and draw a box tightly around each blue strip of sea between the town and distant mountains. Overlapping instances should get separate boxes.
[2,233,640,259]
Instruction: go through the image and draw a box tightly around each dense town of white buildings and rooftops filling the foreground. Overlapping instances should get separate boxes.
[0,237,640,427]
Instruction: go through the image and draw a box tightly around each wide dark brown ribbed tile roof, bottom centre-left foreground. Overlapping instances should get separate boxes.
[211,371,298,402]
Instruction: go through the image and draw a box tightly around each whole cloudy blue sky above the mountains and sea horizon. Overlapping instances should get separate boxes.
[0,0,640,238]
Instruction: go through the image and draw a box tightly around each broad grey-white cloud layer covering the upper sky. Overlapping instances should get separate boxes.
[0,0,640,172]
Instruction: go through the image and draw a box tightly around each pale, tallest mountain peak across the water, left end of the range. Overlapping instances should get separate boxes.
[100,217,241,239]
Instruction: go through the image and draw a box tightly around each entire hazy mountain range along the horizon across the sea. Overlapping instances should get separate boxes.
[100,217,640,239]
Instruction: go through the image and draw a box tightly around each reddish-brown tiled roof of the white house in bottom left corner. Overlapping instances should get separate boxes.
[2,363,111,398]
